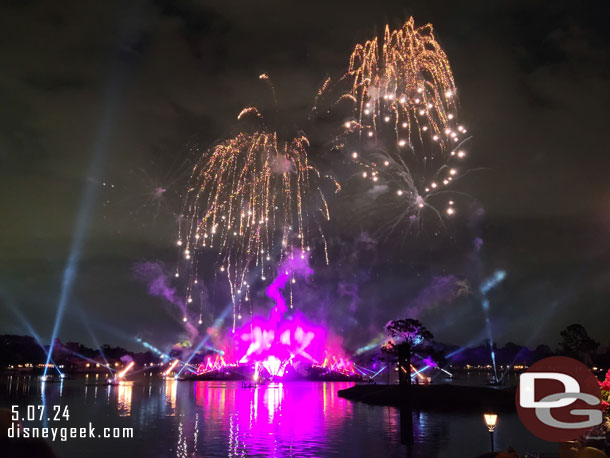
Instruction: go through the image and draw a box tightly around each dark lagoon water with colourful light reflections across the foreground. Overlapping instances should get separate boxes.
[0,375,557,458]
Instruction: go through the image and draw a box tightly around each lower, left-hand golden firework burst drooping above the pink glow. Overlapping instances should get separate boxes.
[176,83,330,329]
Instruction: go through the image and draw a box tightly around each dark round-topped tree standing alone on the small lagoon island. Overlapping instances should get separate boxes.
[382,318,433,386]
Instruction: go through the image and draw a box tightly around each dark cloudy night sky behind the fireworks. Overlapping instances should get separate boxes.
[0,0,610,349]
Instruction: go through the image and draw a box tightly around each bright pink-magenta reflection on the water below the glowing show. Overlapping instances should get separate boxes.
[194,381,353,456]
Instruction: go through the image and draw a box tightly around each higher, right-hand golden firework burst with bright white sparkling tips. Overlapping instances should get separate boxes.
[315,18,467,233]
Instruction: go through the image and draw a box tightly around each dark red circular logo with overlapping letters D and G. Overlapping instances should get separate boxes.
[515,356,603,442]
